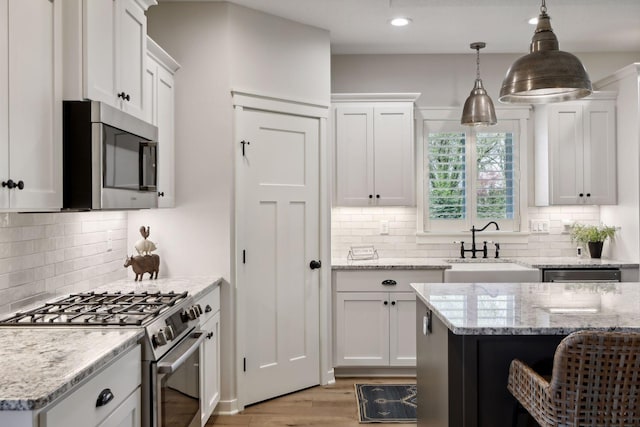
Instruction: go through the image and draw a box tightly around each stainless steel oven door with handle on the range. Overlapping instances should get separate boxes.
[153,331,205,427]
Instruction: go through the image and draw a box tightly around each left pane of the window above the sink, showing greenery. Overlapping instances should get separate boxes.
[427,132,466,219]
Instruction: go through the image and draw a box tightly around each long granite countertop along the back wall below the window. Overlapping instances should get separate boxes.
[331,257,640,270]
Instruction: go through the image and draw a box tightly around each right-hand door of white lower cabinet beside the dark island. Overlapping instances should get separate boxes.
[389,292,416,366]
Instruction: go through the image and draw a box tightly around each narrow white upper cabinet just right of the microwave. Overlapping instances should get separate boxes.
[144,38,180,208]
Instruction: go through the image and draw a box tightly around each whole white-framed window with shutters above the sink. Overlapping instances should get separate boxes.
[418,113,528,234]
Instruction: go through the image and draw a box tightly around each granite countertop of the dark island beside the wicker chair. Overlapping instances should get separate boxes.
[411,282,640,335]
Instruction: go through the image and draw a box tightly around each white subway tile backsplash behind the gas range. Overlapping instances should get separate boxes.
[0,212,127,313]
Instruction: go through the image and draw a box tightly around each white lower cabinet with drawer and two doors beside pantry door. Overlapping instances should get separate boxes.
[333,270,442,367]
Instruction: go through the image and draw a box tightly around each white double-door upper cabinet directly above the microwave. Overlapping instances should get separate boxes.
[64,0,157,120]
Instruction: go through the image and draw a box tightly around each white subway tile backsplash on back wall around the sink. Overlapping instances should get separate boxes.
[331,206,600,258]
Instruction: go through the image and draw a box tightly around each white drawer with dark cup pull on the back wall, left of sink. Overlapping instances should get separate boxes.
[333,270,443,292]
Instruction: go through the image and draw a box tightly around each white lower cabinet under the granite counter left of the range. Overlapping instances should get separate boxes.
[39,345,141,427]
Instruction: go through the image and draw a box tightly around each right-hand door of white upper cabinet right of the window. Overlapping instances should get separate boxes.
[582,101,617,205]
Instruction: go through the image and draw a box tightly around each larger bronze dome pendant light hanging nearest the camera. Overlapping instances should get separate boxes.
[499,0,593,104]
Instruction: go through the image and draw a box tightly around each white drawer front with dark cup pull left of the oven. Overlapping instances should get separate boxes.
[41,345,141,427]
